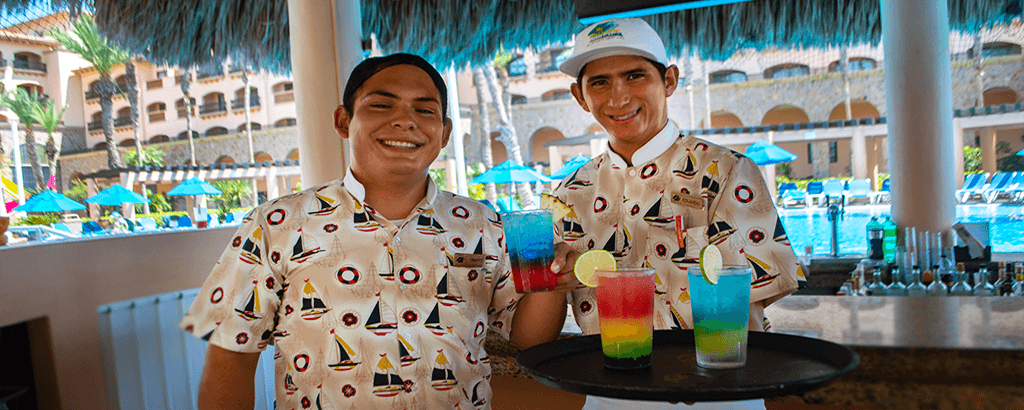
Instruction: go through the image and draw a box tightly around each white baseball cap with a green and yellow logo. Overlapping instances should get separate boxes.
[558,18,669,78]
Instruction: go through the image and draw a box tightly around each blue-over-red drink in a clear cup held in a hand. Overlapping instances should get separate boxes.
[502,209,558,293]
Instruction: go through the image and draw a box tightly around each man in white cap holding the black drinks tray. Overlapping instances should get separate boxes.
[554,18,806,410]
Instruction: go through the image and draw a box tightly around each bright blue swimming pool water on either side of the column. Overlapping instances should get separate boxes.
[778,204,1024,255]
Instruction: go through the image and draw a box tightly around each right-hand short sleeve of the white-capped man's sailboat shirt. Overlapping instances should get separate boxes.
[706,154,807,304]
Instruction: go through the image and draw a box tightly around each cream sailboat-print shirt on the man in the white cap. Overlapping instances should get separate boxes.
[555,121,806,334]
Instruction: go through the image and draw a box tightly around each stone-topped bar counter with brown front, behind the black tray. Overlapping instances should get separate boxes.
[486,295,1024,409]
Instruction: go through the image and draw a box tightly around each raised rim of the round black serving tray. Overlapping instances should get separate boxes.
[515,329,860,402]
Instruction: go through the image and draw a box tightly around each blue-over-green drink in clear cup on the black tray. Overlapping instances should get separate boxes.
[686,264,752,369]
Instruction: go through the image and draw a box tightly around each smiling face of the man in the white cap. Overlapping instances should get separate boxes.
[571,55,679,155]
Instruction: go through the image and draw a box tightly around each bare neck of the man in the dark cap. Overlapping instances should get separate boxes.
[352,171,427,220]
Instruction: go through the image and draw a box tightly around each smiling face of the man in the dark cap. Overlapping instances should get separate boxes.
[335,65,452,183]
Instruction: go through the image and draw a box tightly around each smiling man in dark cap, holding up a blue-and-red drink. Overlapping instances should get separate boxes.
[181,54,575,410]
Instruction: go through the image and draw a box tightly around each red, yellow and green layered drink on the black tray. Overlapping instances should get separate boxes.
[596,268,654,370]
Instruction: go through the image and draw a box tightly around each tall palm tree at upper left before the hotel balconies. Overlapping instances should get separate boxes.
[50,15,129,169]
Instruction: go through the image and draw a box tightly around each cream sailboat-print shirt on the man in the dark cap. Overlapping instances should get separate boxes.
[181,172,520,410]
